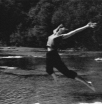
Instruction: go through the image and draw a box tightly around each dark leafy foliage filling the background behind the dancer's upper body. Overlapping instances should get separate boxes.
[0,0,102,50]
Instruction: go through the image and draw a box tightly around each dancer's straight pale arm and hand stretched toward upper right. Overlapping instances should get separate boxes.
[63,22,96,39]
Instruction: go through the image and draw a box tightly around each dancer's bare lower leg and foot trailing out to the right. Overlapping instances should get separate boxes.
[75,75,95,92]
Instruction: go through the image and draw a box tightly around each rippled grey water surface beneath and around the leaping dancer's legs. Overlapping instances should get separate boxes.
[0,53,102,104]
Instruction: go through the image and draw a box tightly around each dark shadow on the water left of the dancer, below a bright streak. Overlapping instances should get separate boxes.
[0,55,45,70]
